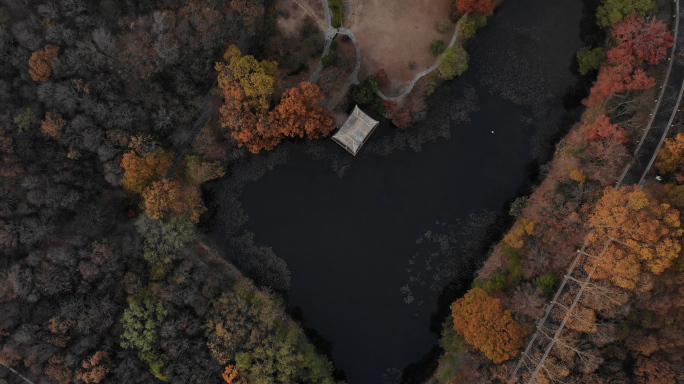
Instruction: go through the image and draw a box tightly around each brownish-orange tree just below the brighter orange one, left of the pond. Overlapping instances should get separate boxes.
[143,179,206,223]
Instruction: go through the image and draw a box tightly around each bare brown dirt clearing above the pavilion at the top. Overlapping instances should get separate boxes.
[343,0,454,96]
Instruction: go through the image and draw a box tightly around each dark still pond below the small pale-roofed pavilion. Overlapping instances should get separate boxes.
[214,0,583,384]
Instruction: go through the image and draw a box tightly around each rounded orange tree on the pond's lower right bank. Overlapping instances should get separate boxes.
[451,288,525,364]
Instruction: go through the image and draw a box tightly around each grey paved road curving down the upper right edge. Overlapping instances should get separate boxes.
[617,2,684,186]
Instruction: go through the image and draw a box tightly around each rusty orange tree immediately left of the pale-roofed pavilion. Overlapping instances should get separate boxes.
[273,82,335,139]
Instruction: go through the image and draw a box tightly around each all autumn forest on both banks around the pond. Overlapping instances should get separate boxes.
[0,0,684,384]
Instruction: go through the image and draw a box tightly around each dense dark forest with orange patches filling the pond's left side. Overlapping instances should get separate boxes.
[0,0,340,383]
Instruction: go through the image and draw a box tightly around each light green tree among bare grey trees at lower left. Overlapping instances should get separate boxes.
[121,291,168,381]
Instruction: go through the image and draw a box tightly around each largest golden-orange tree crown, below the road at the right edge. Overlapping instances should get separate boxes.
[587,188,682,291]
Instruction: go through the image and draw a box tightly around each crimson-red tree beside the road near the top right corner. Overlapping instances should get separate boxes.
[608,12,673,66]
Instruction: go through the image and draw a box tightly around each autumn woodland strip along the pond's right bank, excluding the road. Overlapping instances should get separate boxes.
[430,0,684,384]
